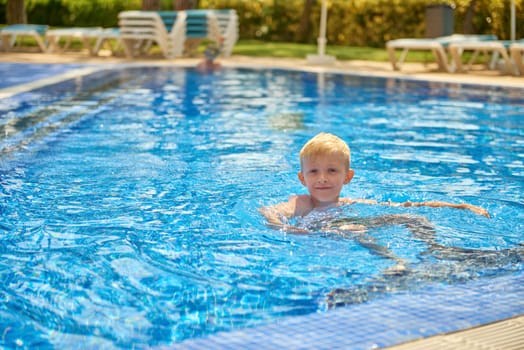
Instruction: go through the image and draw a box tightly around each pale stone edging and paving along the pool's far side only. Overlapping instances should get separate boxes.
[0,53,524,99]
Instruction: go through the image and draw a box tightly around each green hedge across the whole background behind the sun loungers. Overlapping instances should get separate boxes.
[0,0,524,47]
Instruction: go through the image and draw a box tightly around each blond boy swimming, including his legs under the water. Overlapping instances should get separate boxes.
[260,133,489,274]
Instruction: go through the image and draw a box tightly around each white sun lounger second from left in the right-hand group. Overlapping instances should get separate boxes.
[448,40,515,74]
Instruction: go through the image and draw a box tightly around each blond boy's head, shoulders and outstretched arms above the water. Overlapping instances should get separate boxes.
[260,133,489,233]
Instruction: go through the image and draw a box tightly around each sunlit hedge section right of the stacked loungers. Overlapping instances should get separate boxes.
[203,0,524,47]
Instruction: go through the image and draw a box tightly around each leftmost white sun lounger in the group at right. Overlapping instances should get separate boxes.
[386,34,497,73]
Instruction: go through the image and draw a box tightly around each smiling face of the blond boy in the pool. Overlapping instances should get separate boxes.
[298,154,354,207]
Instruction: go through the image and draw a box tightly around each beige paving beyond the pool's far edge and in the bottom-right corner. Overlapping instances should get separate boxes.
[0,53,524,350]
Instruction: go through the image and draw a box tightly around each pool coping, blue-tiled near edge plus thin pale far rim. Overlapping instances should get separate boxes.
[0,62,524,350]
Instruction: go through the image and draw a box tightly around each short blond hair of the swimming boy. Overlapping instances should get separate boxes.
[300,132,351,169]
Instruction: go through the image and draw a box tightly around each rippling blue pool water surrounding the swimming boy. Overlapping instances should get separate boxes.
[0,68,524,348]
